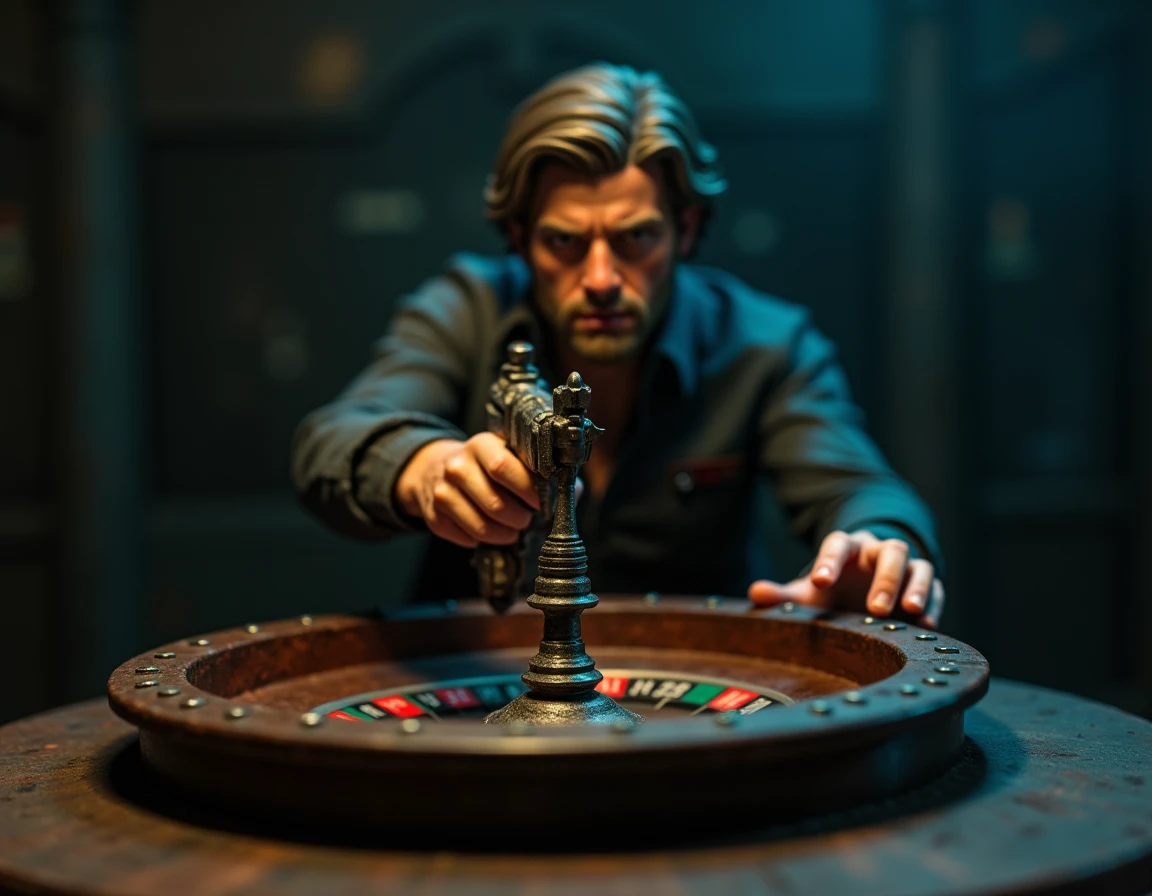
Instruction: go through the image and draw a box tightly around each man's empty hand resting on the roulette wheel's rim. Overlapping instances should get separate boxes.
[748,530,943,629]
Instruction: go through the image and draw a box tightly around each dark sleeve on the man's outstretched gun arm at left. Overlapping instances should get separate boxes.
[291,273,483,539]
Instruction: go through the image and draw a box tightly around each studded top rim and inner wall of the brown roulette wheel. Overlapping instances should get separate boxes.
[108,597,988,757]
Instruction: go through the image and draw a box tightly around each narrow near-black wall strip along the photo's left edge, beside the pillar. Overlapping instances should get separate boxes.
[0,0,54,719]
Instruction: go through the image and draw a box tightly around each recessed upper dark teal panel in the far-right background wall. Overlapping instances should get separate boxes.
[973,61,1126,484]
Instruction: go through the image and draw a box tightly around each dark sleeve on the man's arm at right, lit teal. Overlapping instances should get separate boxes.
[758,312,942,570]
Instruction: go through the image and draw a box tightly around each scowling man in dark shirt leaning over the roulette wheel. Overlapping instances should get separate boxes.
[294,64,943,627]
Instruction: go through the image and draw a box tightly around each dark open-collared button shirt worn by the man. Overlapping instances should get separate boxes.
[293,255,940,600]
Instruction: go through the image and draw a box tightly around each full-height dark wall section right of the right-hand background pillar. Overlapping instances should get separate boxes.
[965,13,1147,709]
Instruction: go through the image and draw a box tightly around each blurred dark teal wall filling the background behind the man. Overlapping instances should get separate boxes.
[0,0,1152,717]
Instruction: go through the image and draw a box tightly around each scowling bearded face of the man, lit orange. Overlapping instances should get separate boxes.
[510,162,680,363]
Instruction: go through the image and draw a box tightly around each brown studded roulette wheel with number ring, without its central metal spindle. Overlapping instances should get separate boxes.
[101,595,987,840]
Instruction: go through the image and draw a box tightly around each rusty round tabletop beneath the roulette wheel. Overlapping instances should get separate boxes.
[0,681,1152,896]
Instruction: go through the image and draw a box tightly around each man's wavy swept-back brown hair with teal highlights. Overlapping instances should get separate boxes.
[484,62,727,244]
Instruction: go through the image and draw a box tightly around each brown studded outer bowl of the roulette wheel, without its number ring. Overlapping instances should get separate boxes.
[101,597,988,840]
